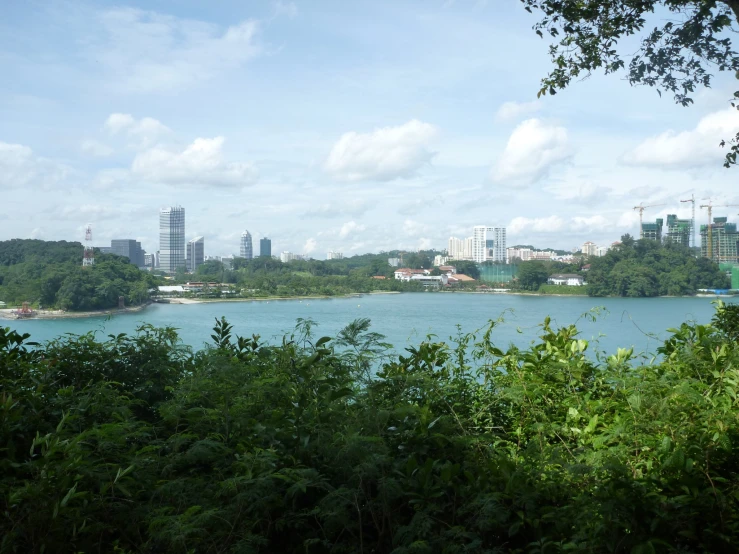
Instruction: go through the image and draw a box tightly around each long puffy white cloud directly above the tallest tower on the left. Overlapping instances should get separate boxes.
[131,137,256,187]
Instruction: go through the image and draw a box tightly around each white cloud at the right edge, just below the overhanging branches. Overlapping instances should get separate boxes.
[621,108,739,168]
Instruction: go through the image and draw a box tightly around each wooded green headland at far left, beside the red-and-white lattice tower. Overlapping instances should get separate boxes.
[0,239,154,310]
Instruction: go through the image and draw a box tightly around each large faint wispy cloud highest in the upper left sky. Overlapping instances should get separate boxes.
[89,8,260,93]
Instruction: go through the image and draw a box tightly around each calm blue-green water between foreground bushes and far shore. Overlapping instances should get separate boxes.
[0,293,736,352]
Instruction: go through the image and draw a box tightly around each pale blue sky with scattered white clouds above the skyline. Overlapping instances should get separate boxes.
[0,0,739,258]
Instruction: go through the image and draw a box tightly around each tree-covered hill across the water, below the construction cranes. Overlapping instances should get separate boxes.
[588,235,729,297]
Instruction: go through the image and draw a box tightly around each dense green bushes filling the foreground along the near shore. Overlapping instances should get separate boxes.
[0,305,739,553]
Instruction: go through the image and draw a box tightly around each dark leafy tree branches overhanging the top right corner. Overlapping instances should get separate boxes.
[521,0,739,167]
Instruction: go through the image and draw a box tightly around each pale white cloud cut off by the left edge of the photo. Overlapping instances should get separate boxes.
[0,142,71,190]
